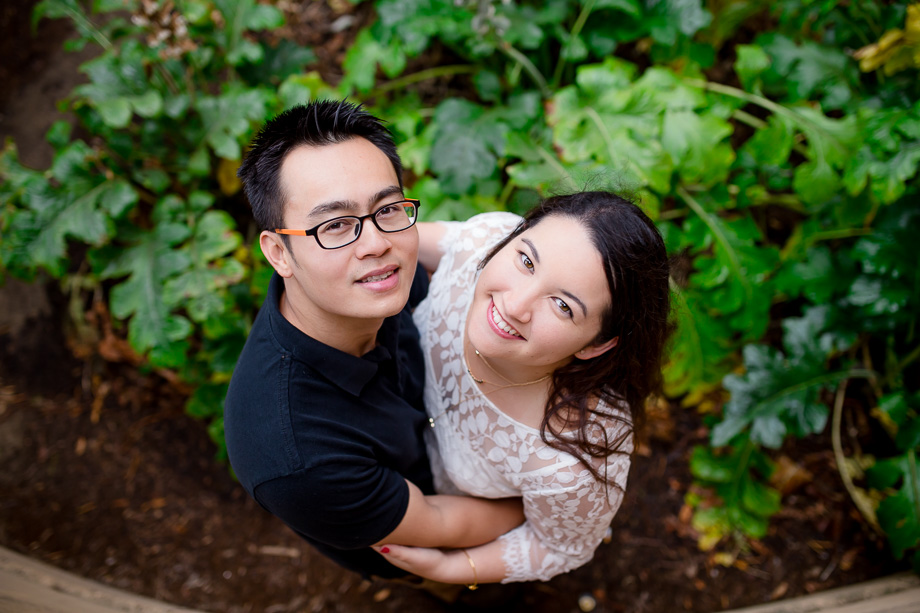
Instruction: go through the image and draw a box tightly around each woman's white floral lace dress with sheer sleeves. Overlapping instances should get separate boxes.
[414,213,633,583]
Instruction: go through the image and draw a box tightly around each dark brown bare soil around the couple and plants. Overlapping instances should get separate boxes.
[0,0,899,613]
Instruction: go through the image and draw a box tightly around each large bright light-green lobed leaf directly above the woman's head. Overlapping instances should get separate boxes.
[548,59,734,194]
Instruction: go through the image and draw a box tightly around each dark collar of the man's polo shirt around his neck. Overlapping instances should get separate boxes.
[263,272,399,396]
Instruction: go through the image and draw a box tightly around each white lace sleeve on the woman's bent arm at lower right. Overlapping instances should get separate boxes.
[499,444,629,583]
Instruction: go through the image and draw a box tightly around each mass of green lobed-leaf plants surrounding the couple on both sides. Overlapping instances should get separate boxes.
[0,0,920,558]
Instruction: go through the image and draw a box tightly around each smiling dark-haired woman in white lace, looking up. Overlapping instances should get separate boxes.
[377,192,669,588]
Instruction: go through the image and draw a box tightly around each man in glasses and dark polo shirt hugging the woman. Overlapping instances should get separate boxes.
[224,101,523,577]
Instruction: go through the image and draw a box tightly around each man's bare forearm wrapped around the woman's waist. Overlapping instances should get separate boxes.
[377,481,524,548]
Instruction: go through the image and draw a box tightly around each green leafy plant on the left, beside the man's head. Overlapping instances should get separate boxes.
[0,0,322,454]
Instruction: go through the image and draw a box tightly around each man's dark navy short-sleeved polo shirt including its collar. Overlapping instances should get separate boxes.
[224,267,434,577]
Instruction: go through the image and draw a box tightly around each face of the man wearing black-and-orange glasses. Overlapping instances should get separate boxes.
[272,138,418,340]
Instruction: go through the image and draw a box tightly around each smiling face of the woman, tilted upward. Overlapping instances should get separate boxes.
[467,215,612,375]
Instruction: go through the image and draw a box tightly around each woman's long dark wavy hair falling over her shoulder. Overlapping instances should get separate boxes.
[479,191,673,486]
